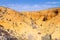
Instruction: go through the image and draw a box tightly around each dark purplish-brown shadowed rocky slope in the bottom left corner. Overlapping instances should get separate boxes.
[0,29,18,40]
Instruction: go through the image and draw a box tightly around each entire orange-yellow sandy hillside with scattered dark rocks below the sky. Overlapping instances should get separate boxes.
[0,7,60,40]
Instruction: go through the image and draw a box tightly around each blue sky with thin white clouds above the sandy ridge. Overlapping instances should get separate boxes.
[0,0,60,11]
